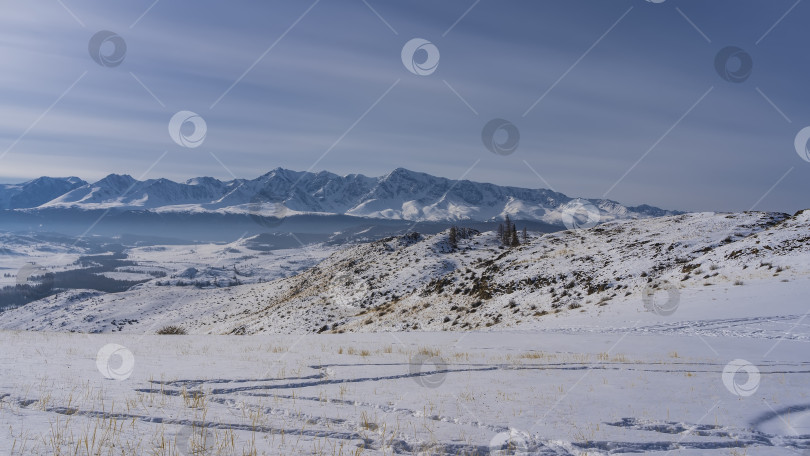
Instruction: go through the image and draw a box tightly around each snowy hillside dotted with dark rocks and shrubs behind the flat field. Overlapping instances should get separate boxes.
[2,211,810,334]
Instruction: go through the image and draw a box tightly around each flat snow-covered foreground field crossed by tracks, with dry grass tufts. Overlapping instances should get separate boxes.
[0,281,810,455]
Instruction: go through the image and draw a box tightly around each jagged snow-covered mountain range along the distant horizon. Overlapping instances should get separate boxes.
[0,168,677,225]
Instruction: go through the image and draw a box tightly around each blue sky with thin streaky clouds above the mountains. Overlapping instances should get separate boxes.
[0,0,810,211]
